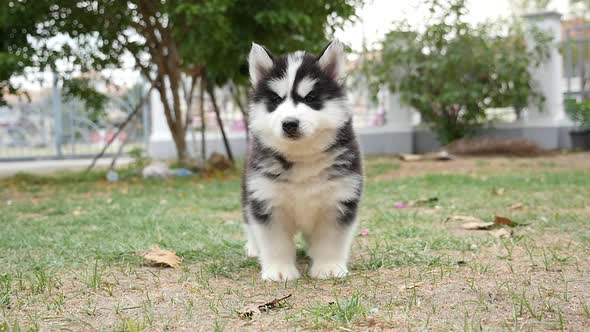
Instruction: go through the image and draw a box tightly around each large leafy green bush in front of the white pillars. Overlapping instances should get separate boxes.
[368,0,548,143]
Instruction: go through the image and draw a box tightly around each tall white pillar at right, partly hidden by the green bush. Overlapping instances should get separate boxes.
[523,11,566,127]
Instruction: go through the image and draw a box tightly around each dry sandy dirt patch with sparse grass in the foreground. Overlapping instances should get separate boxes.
[5,237,590,331]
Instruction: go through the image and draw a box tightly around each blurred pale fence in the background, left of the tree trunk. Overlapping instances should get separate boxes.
[0,76,149,161]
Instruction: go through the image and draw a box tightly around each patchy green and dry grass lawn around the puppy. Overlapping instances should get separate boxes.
[0,154,590,331]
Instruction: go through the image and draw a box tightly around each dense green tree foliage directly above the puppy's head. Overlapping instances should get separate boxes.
[173,0,361,83]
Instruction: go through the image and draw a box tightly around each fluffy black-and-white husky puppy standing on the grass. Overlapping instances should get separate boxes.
[242,42,363,281]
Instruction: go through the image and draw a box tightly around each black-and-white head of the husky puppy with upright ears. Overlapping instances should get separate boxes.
[249,42,351,155]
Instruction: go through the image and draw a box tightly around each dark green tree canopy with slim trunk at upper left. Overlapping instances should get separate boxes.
[0,0,364,162]
